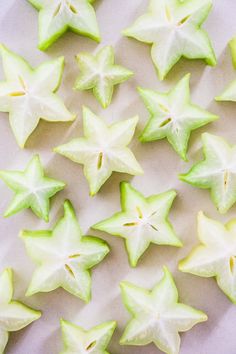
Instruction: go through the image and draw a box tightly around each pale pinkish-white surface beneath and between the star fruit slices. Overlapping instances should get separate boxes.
[0,0,236,354]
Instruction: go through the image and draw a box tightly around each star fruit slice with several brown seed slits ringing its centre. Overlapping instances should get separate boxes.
[93,182,182,267]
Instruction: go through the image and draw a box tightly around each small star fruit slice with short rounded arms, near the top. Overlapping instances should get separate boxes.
[75,46,133,108]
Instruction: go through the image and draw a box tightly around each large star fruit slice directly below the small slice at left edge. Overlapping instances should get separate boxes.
[20,201,109,302]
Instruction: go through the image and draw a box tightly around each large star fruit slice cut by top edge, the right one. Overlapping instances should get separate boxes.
[123,0,216,80]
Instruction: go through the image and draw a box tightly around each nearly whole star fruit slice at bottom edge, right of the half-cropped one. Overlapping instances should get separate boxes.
[120,267,207,354]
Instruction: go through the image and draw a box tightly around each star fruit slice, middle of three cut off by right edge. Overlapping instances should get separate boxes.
[179,133,236,214]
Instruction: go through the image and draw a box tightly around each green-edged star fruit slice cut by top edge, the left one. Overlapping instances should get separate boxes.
[28,0,100,50]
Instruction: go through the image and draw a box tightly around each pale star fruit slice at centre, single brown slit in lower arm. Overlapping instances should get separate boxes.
[55,107,143,195]
